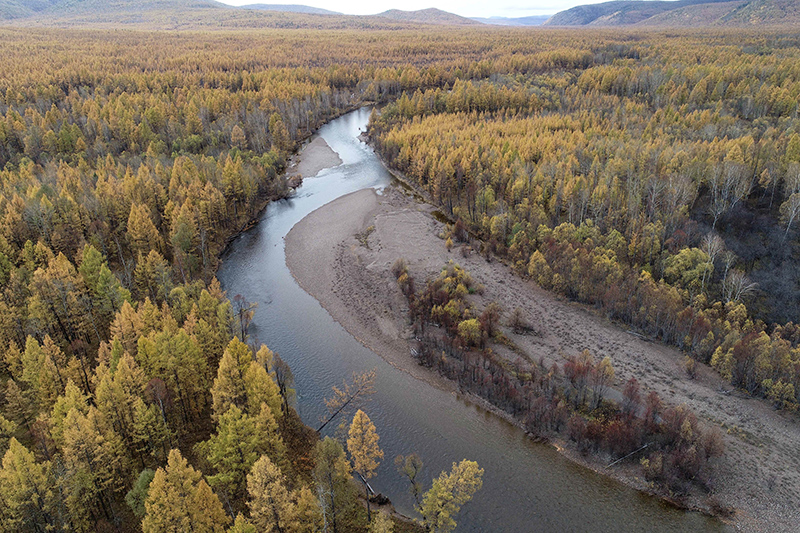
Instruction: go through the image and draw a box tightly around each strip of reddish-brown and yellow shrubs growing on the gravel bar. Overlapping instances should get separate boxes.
[393,259,725,496]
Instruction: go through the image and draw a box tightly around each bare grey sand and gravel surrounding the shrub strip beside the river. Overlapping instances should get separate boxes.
[286,156,800,531]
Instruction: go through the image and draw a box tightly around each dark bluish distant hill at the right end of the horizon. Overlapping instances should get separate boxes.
[544,0,800,27]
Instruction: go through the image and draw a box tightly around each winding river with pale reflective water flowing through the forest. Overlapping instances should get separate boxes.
[218,108,725,533]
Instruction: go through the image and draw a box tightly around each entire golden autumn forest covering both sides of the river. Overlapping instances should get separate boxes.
[0,22,800,533]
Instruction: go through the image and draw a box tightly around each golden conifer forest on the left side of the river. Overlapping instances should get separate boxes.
[0,26,506,532]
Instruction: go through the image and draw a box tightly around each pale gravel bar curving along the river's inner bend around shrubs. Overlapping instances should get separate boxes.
[286,182,800,531]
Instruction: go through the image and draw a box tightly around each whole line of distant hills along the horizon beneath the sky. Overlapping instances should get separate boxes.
[7,0,800,29]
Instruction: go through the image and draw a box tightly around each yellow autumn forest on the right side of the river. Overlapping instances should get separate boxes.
[371,30,800,410]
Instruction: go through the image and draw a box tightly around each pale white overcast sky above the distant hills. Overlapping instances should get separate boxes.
[220,0,603,17]
